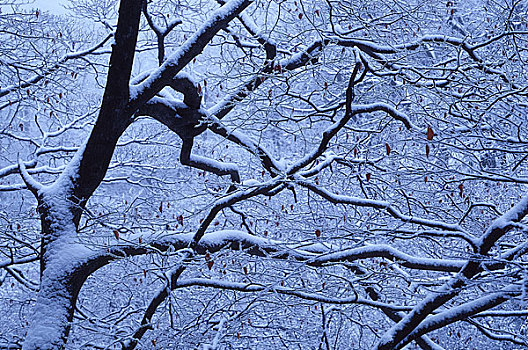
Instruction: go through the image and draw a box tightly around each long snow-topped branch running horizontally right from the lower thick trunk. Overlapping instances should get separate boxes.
[88,230,464,282]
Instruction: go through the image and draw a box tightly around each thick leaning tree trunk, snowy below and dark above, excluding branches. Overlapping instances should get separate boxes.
[22,0,143,350]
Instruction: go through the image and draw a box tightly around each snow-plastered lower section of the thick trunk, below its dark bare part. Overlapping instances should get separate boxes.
[22,168,90,350]
